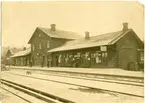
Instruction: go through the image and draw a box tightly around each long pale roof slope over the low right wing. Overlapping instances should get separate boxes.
[48,29,132,52]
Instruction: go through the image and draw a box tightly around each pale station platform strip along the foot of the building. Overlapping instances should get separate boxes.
[7,66,144,78]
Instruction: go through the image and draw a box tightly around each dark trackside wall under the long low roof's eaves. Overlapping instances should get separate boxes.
[52,47,116,68]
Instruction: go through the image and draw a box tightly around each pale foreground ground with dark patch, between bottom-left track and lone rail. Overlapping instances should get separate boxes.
[2,73,143,103]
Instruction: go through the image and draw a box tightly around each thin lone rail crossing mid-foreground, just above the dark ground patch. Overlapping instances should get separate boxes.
[3,73,144,98]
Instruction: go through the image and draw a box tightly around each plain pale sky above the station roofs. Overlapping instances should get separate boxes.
[2,1,144,47]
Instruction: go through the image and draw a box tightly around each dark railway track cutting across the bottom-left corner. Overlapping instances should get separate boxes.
[1,79,75,103]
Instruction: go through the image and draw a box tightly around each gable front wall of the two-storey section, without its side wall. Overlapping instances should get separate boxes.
[31,29,50,66]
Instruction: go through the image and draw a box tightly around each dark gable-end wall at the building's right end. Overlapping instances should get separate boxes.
[116,32,139,69]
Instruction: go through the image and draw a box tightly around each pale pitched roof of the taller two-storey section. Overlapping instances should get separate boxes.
[28,27,81,43]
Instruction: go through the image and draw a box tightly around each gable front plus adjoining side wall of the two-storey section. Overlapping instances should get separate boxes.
[31,29,71,66]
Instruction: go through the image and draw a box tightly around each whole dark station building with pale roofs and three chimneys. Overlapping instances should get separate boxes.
[12,22,144,70]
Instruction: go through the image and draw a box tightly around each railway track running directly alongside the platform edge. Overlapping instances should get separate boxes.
[10,67,144,83]
